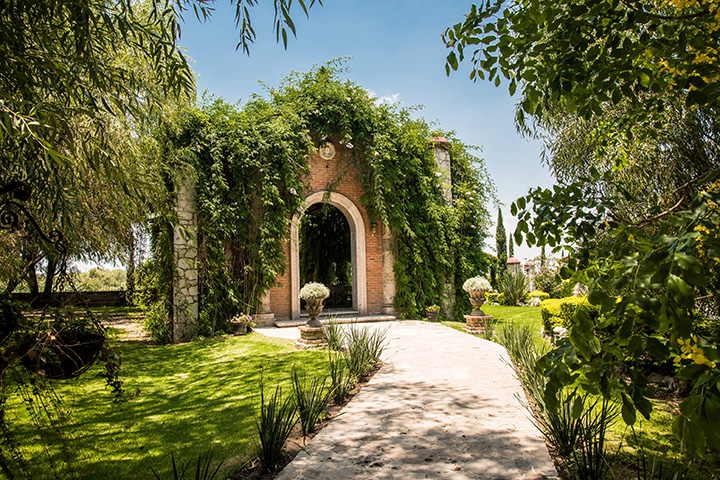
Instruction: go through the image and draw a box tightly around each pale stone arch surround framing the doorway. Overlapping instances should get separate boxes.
[290,191,368,320]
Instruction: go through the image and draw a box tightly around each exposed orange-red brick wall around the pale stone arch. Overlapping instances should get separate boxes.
[270,140,383,318]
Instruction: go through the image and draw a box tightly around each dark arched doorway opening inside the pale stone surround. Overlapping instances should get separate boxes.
[298,203,353,313]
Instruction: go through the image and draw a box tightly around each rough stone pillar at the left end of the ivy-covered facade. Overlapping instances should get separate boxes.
[173,174,198,343]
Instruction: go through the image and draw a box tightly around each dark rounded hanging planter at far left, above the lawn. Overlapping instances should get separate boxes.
[19,330,105,380]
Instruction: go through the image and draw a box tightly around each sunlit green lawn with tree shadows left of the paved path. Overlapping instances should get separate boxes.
[8,334,327,479]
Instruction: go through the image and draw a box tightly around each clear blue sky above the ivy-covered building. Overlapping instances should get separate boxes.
[179,0,553,260]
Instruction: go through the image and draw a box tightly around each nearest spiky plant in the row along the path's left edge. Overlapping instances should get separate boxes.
[256,374,296,473]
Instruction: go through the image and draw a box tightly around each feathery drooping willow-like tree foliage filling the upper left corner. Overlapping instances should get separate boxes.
[0,0,315,292]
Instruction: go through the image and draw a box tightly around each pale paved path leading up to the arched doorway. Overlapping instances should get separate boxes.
[259,321,557,480]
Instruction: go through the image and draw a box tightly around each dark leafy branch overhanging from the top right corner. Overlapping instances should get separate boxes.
[443,0,720,122]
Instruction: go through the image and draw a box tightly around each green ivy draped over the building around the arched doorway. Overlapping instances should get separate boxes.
[155,61,494,338]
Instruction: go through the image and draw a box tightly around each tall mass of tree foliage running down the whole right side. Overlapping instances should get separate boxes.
[444,0,720,457]
